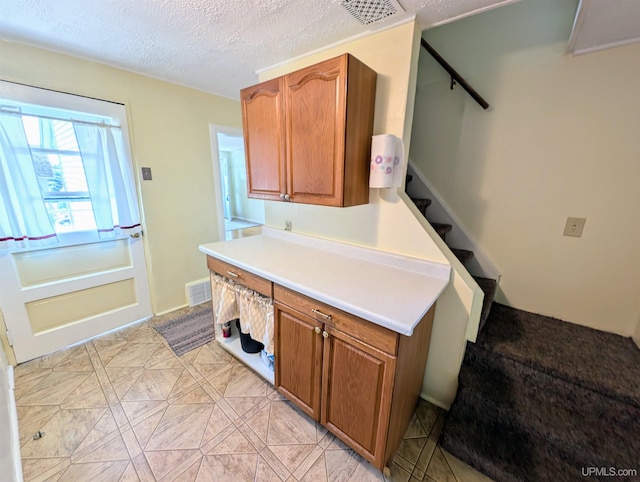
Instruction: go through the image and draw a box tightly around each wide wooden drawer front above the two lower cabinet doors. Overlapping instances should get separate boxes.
[273,284,399,356]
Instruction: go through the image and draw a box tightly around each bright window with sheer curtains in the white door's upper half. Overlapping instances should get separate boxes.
[0,81,140,248]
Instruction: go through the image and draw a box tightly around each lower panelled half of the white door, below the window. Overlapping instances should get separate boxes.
[0,237,151,363]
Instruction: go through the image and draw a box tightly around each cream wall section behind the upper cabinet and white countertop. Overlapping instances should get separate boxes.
[260,23,481,408]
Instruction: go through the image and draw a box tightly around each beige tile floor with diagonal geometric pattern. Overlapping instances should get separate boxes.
[15,310,496,482]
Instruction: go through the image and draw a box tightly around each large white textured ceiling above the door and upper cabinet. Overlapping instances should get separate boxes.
[0,0,516,99]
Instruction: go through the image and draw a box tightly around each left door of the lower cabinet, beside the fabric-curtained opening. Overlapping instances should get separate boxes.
[274,303,322,421]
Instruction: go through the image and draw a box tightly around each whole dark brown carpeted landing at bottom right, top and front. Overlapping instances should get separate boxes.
[441,304,640,481]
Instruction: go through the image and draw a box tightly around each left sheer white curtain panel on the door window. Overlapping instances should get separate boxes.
[0,112,57,248]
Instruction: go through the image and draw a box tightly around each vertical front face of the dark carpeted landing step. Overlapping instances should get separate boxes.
[442,344,640,481]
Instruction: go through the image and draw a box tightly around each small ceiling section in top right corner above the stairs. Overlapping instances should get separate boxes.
[569,0,640,54]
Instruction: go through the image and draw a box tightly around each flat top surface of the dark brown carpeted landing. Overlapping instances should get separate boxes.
[477,303,640,408]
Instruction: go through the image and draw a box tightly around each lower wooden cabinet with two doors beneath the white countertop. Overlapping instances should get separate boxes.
[274,285,433,469]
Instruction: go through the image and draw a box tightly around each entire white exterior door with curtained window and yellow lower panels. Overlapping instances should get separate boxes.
[0,82,151,362]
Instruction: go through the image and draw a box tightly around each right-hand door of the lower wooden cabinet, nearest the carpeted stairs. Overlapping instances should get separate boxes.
[321,328,395,468]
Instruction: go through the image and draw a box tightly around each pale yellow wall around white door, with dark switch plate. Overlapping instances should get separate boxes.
[0,41,242,313]
